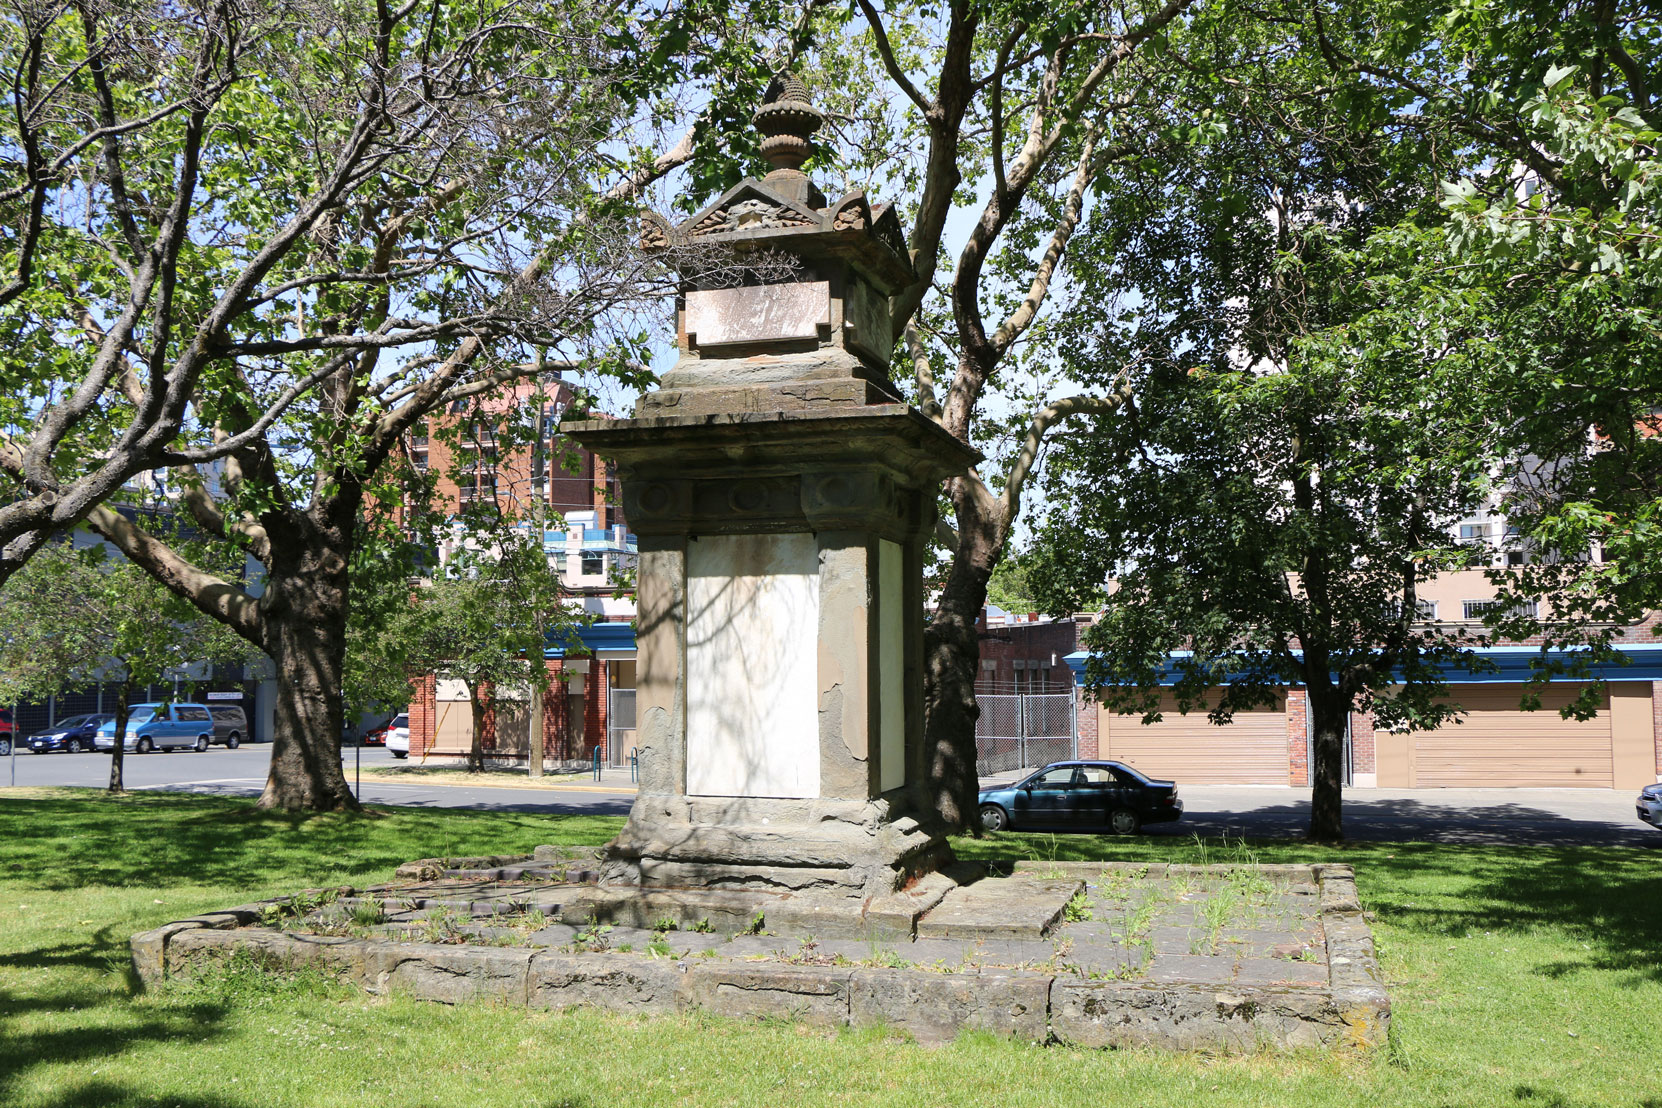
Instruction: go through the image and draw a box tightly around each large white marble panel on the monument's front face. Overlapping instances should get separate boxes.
[686,535,819,797]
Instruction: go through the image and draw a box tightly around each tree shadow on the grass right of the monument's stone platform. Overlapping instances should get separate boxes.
[954,832,1662,983]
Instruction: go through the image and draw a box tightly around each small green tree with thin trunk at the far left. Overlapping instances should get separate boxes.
[0,542,258,792]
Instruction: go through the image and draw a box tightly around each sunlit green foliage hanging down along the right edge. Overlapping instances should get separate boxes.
[1315,0,1662,664]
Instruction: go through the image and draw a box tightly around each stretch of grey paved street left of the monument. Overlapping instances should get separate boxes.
[0,743,635,816]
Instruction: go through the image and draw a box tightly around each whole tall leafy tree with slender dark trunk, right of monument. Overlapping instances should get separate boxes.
[1003,3,1501,839]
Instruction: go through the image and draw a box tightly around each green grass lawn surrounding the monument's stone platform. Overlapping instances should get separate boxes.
[0,789,1662,1108]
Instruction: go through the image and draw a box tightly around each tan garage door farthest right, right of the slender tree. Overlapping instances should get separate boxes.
[1413,684,1612,789]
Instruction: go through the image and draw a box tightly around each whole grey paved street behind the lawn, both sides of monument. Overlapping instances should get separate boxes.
[0,744,1662,851]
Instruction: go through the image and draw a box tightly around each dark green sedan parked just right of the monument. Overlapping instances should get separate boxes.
[981,762,1183,836]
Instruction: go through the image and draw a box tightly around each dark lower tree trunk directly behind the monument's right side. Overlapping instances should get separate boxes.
[924,540,997,834]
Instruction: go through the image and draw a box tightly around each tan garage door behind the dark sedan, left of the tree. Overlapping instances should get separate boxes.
[1097,701,1288,786]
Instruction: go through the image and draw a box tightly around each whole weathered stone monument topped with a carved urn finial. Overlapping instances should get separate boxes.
[563,80,979,902]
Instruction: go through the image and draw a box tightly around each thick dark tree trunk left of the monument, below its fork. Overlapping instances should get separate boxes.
[259,558,359,811]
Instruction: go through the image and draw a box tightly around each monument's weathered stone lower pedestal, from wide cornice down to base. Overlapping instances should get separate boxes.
[577,405,967,897]
